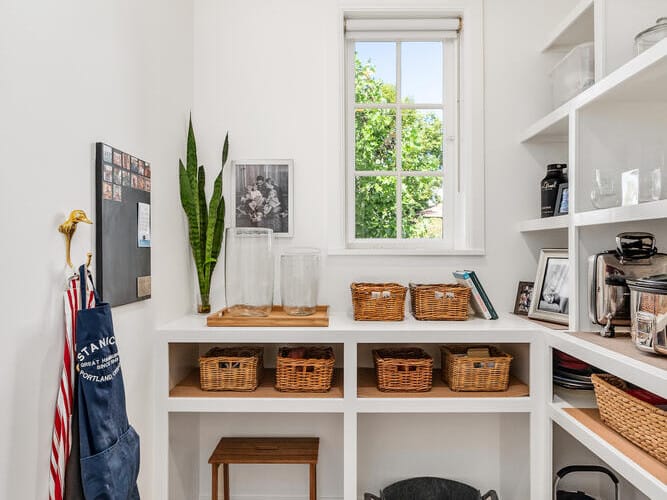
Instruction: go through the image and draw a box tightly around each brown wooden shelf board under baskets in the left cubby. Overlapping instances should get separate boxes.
[169,369,343,399]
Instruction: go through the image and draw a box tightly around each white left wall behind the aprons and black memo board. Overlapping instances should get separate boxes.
[0,0,193,499]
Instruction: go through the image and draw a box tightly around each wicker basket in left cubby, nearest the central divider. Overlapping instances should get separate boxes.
[276,347,336,392]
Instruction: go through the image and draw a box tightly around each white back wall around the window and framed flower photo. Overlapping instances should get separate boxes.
[194,0,567,311]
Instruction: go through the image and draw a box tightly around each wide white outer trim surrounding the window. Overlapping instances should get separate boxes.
[332,0,485,256]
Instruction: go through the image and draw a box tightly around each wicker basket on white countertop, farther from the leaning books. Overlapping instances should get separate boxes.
[350,283,407,321]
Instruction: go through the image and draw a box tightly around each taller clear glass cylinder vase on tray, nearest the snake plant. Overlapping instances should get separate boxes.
[225,227,273,316]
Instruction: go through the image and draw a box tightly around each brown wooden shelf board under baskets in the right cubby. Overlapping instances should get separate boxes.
[357,368,529,398]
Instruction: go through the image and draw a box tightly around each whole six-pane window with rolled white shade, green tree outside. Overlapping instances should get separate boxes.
[345,18,474,251]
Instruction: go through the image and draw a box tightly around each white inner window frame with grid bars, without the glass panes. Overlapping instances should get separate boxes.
[345,27,459,250]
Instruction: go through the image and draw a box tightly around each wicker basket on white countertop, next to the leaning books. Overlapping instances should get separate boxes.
[410,283,470,321]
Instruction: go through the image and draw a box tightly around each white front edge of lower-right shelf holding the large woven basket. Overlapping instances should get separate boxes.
[548,400,667,499]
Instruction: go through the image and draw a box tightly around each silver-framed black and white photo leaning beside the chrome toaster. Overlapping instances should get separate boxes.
[528,249,570,325]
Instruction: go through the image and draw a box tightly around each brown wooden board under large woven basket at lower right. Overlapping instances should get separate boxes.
[563,408,667,485]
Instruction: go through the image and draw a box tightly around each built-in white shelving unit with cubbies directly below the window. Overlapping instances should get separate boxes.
[156,313,548,500]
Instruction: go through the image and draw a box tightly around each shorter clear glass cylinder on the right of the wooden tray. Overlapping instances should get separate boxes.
[280,248,320,316]
